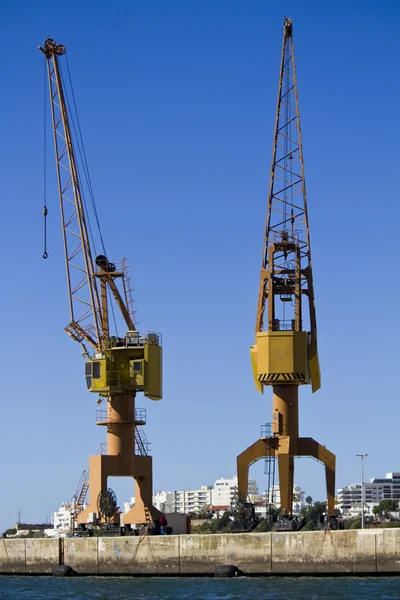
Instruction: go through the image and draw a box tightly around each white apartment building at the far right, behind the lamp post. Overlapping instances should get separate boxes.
[336,473,400,518]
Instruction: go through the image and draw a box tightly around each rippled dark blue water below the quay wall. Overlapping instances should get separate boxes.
[0,577,400,600]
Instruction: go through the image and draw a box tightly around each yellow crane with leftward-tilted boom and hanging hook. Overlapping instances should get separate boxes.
[39,38,162,525]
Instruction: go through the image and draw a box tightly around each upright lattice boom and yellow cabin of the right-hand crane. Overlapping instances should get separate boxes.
[251,19,321,392]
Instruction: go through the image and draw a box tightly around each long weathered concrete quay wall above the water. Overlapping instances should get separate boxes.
[0,529,400,575]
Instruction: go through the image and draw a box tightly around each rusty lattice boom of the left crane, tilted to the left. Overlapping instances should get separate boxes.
[39,38,102,351]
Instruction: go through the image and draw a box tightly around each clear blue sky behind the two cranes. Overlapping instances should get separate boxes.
[0,0,400,531]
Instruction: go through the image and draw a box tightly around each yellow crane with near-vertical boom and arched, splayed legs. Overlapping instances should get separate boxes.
[237,17,335,516]
